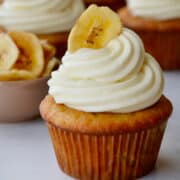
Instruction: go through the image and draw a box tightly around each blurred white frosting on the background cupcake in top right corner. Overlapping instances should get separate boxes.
[127,0,180,20]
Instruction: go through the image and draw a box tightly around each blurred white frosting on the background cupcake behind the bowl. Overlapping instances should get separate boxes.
[0,0,84,34]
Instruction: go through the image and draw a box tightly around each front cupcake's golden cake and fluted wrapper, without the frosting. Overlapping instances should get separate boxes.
[40,96,172,180]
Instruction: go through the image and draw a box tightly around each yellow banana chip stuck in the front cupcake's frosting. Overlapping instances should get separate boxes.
[68,5,122,52]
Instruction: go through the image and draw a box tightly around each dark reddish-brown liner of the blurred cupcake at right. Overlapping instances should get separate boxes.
[135,30,180,70]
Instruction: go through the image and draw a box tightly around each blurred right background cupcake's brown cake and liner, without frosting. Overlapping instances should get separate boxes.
[119,7,180,70]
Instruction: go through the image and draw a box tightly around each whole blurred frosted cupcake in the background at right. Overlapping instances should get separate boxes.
[119,0,180,70]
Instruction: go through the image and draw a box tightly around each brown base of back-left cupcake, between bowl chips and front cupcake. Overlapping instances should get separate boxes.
[38,32,69,58]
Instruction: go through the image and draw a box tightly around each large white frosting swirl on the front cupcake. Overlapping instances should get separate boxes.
[48,29,163,113]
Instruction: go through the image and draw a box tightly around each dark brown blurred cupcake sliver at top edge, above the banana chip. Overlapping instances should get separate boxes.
[84,0,125,10]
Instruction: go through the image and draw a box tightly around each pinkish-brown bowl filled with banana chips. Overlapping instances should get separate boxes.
[0,31,59,122]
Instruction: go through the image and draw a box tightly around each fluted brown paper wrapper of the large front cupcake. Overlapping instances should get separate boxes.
[48,123,166,180]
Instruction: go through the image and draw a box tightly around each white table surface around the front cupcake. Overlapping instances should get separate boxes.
[0,72,180,180]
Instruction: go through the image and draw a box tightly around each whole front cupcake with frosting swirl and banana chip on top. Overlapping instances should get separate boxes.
[40,5,172,180]
